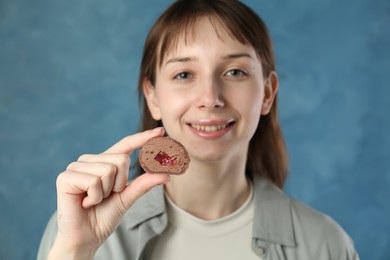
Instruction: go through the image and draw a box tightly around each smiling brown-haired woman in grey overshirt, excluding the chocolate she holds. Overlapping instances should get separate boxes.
[38,0,358,260]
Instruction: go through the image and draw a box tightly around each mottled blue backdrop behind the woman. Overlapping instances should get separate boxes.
[0,0,390,260]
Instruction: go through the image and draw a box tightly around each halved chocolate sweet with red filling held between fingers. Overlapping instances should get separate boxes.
[138,137,191,175]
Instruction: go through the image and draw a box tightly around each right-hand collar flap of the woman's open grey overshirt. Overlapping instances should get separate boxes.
[253,174,296,247]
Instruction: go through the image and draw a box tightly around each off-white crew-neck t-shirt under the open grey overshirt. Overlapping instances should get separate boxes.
[145,185,259,260]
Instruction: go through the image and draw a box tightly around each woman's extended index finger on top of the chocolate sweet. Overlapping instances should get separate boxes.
[103,127,164,154]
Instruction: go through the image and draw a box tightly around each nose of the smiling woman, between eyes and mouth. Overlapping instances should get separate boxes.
[196,79,225,109]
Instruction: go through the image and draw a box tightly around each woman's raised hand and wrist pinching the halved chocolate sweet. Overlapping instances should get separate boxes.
[49,128,169,259]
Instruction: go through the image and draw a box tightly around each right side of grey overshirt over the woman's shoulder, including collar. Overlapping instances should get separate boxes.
[253,177,358,259]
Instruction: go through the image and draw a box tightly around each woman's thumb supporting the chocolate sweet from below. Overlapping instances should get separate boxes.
[120,173,170,211]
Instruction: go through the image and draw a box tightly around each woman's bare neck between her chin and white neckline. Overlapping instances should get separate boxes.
[166,157,250,220]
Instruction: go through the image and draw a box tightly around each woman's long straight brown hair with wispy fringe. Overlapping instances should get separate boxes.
[138,0,288,188]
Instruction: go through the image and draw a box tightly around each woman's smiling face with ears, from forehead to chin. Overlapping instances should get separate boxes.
[144,19,277,162]
